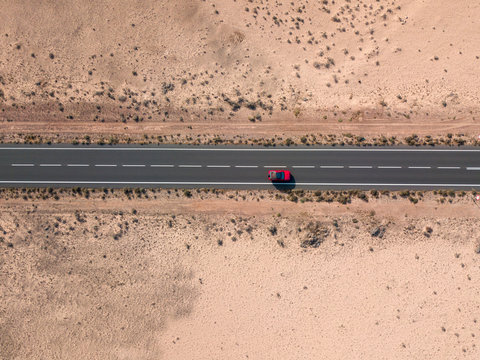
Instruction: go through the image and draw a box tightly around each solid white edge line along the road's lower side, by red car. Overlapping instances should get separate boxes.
[0,181,480,188]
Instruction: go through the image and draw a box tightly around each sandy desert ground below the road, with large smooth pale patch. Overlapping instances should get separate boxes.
[0,192,480,359]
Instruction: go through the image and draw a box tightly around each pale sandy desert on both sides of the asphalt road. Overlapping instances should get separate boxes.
[0,0,480,360]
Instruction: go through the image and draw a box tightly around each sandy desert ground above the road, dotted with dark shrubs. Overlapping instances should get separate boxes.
[0,0,480,141]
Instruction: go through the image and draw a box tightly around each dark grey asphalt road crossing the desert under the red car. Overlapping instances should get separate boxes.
[0,146,480,190]
